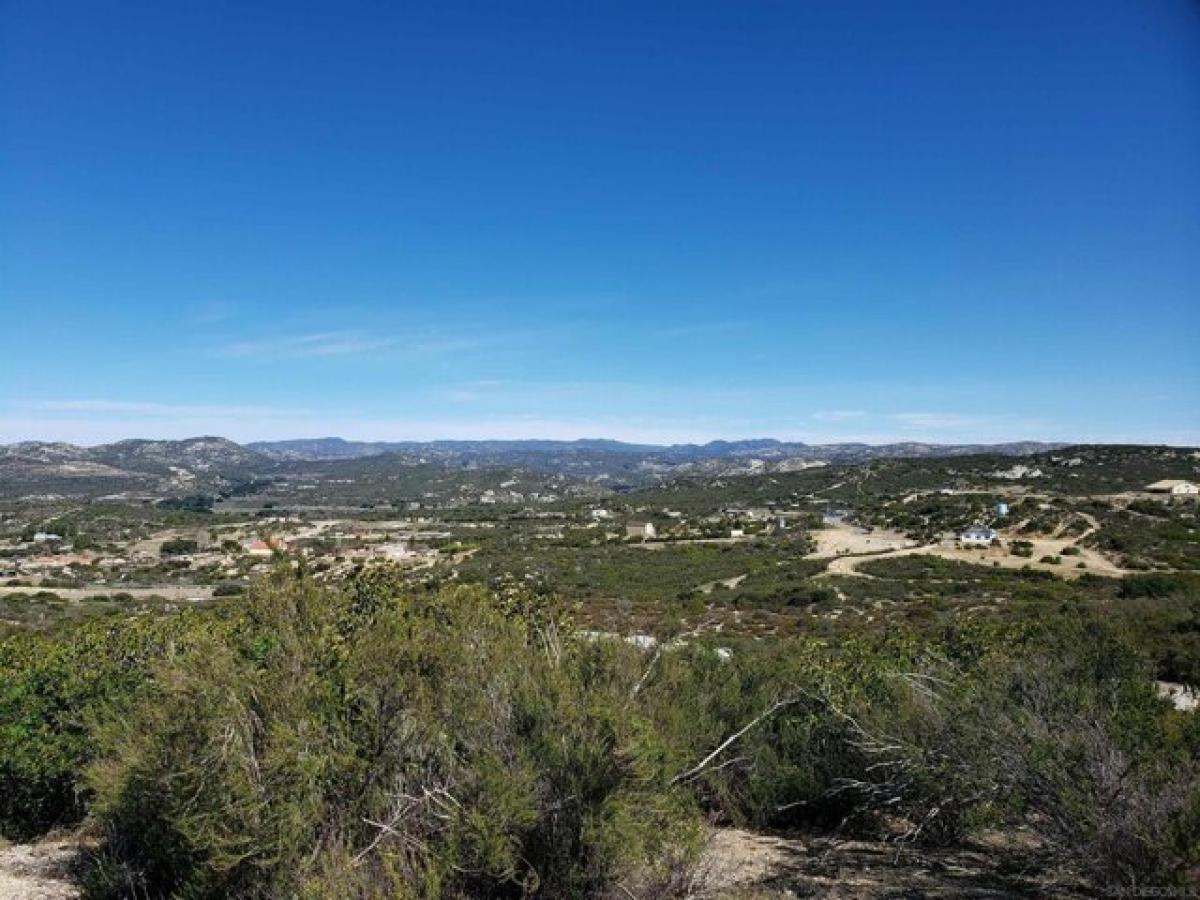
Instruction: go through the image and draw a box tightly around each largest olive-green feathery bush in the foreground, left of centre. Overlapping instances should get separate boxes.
[90,575,700,898]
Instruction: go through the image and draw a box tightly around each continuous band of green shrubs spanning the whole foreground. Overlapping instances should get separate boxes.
[0,570,1200,898]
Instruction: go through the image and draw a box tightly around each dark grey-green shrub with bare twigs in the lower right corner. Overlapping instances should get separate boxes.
[835,618,1200,887]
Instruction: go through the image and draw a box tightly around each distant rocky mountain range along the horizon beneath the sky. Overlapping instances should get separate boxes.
[0,437,1200,499]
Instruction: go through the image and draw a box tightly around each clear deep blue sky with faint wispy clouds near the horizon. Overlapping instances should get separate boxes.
[0,0,1200,444]
